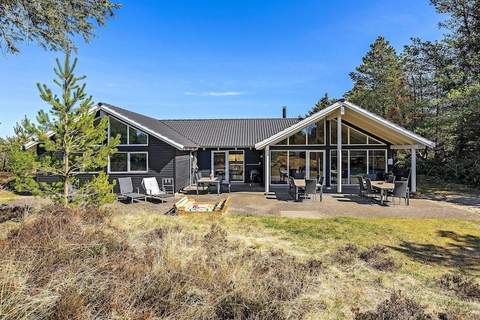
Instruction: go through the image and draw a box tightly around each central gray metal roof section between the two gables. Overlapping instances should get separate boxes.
[160,118,299,148]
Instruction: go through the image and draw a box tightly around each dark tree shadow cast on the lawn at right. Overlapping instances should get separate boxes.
[390,230,480,272]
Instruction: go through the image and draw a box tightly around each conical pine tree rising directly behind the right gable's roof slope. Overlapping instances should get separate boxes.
[345,37,408,123]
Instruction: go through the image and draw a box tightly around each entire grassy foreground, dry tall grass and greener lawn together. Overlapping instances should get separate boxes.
[0,199,480,319]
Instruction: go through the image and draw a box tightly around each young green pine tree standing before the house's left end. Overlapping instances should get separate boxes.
[18,54,119,206]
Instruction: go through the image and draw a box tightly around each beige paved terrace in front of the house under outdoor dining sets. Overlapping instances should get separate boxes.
[176,185,480,220]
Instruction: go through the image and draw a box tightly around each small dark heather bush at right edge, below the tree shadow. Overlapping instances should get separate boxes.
[439,273,480,301]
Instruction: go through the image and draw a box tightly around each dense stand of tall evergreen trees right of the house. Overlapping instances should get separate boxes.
[310,0,480,185]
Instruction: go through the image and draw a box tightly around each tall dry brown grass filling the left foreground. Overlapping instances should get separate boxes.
[0,207,322,319]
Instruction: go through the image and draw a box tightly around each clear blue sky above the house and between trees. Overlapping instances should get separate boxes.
[0,0,442,136]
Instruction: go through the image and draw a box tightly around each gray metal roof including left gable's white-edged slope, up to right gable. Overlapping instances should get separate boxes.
[100,103,300,148]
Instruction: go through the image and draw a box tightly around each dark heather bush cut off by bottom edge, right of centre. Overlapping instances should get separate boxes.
[354,292,433,320]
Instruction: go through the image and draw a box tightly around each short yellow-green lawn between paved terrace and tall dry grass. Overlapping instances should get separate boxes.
[111,212,480,319]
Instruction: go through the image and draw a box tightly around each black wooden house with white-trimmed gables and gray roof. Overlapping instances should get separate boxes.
[27,100,435,192]
